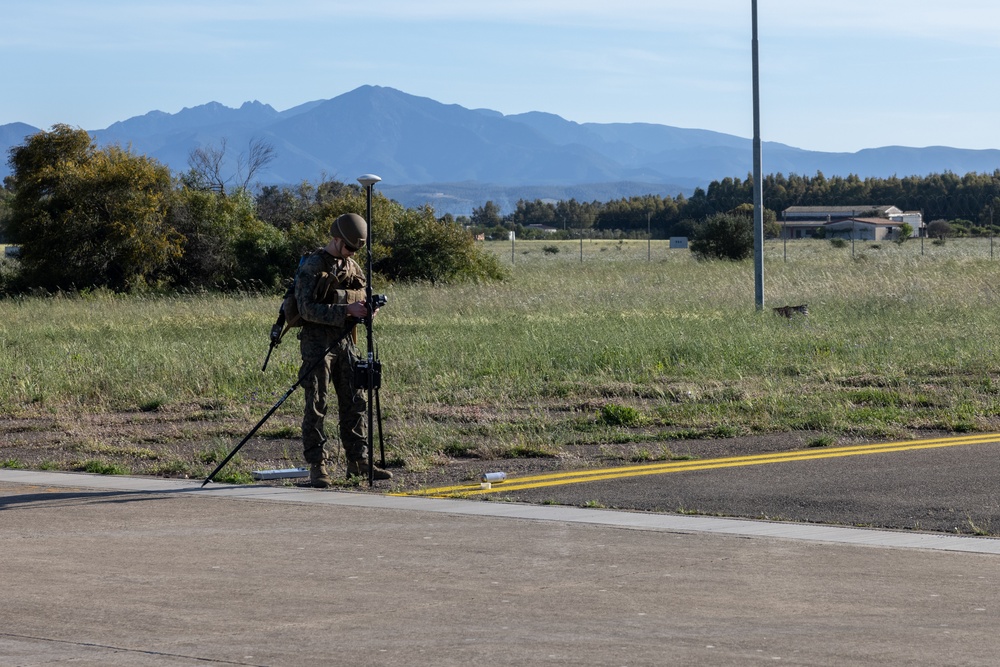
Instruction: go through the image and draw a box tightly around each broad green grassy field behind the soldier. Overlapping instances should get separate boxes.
[0,239,1000,475]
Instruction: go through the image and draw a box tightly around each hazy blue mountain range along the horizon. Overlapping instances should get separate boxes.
[0,86,1000,215]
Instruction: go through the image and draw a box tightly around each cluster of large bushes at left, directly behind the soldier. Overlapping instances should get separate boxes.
[0,125,505,294]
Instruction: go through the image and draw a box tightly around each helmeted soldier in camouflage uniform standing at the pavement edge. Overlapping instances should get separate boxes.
[295,213,392,488]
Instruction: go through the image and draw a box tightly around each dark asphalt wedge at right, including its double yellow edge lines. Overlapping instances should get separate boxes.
[404,434,1000,535]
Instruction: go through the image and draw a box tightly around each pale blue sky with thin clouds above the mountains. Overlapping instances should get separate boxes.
[7,0,1000,151]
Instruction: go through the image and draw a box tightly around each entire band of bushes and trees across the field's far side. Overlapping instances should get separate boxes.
[0,125,1000,294]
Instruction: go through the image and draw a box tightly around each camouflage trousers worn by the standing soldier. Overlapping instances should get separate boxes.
[299,323,368,463]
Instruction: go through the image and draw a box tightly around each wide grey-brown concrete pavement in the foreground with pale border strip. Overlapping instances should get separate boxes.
[0,464,1000,667]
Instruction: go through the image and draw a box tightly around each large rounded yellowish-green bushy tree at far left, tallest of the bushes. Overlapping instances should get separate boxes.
[8,125,181,291]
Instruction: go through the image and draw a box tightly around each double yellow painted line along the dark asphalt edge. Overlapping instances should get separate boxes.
[393,433,1000,498]
